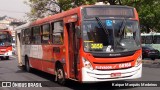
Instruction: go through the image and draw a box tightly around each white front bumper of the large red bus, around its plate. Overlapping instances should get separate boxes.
[82,64,142,83]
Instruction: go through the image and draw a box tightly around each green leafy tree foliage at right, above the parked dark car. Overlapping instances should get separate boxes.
[122,0,160,32]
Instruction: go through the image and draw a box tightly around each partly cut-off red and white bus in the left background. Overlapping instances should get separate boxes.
[0,30,12,60]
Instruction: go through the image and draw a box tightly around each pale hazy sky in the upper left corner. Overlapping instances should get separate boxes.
[0,0,30,20]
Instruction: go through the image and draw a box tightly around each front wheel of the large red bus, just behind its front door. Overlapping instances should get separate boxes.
[56,65,66,85]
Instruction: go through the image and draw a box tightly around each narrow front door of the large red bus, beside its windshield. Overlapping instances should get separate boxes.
[67,22,78,79]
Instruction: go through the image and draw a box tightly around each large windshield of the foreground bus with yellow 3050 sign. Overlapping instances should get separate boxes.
[83,19,141,53]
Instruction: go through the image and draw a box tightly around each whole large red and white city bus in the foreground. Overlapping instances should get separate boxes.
[16,5,142,84]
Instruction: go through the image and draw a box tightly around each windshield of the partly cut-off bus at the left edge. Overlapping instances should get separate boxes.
[0,33,12,46]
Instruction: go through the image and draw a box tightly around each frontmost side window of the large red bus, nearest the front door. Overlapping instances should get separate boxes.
[52,21,64,45]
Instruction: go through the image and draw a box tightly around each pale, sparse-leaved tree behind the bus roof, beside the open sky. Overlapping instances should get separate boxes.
[25,0,57,20]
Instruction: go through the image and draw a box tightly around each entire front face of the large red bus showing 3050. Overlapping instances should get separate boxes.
[82,6,142,82]
